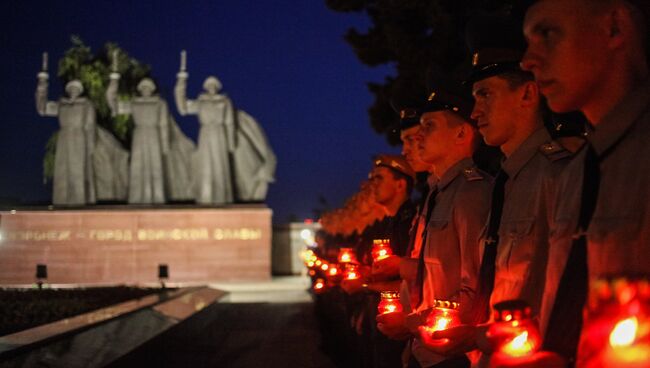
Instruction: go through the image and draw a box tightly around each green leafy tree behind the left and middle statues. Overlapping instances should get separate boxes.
[43,36,151,181]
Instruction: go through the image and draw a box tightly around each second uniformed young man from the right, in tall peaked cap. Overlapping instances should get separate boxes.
[422,17,571,366]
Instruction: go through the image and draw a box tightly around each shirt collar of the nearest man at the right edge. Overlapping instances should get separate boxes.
[587,80,650,155]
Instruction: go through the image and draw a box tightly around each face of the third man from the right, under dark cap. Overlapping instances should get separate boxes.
[418,111,460,165]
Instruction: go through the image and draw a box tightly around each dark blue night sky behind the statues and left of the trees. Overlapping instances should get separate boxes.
[0,0,396,222]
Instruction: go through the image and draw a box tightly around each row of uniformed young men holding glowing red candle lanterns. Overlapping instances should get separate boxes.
[310,0,650,367]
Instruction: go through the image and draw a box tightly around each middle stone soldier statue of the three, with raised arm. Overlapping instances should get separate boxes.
[106,51,194,204]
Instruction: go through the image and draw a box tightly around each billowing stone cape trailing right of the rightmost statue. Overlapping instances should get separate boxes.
[233,110,277,202]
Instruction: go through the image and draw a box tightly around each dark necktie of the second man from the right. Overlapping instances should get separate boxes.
[471,169,508,324]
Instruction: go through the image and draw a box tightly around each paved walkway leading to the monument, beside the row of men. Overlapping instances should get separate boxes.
[110,277,334,368]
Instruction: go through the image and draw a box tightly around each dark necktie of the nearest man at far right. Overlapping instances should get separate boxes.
[544,144,600,363]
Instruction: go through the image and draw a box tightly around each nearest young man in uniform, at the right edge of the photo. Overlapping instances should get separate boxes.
[522,0,650,365]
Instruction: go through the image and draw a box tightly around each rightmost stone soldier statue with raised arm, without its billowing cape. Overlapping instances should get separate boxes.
[174,51,235,204]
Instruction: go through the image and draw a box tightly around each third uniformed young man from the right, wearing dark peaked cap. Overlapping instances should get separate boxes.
[378,82,491,367]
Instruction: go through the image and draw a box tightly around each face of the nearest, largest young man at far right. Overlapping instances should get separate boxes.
[521,0,612,112]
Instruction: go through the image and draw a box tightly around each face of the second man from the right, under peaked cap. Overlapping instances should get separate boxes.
[471,76,524,146]
